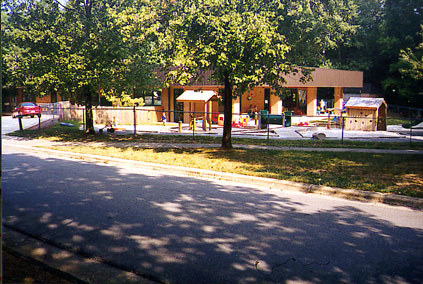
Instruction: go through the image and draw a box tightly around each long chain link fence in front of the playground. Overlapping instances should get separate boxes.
[40,102,423,142]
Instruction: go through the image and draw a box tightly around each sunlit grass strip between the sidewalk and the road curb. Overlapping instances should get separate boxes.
[46,146,423,197]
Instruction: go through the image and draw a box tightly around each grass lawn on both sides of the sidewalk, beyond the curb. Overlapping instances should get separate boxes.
[9,120,423,197]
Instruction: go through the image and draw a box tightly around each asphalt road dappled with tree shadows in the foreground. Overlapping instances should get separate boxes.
[3,146,423,283]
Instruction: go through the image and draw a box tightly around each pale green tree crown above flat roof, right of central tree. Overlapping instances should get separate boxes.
[278,0,362,67]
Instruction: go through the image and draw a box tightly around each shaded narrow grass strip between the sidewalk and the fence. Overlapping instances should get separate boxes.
[9,121,423,150]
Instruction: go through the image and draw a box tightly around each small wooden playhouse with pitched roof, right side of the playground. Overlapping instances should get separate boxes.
[345,97,388,131]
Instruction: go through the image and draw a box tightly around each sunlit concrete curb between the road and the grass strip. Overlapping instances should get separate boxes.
[8,145,423,209]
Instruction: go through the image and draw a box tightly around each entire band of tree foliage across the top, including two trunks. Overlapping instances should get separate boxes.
[1,0,423,137]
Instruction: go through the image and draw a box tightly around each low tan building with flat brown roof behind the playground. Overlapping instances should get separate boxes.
[161,68,363,122]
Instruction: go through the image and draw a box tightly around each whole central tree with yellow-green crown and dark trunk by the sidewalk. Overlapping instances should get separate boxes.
[166,0,310,149]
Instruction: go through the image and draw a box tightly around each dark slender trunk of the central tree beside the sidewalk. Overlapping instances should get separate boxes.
[222,73,232,150]
